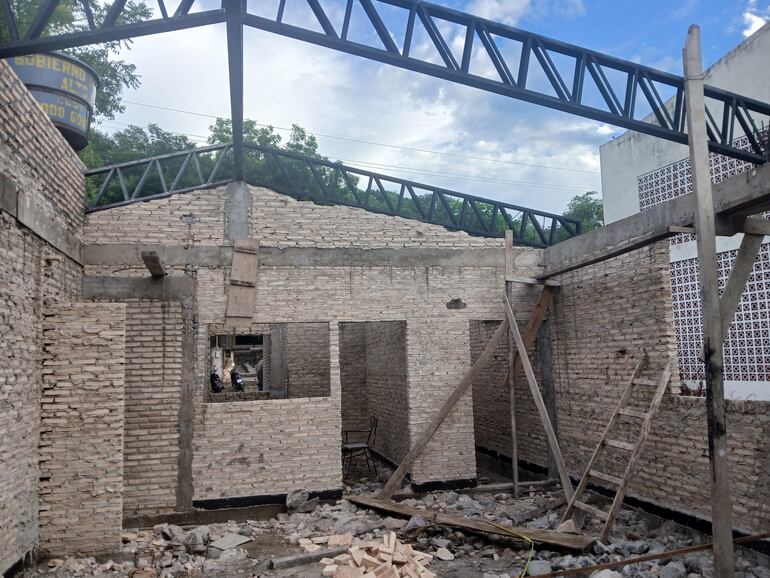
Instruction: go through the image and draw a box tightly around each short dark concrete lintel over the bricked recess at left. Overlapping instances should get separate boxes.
[83,275,195,301]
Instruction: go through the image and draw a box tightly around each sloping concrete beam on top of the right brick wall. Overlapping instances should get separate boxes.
[539,163,770,279]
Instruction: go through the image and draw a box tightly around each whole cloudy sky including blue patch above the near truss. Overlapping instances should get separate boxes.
[105,0,770,213]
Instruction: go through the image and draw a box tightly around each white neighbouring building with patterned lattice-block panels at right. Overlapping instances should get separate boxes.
[600,23,770,399]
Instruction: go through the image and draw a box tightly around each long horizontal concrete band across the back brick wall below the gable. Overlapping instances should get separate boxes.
[84,244,542,269]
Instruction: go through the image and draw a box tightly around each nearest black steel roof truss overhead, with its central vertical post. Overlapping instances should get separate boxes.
[0,0,770,163]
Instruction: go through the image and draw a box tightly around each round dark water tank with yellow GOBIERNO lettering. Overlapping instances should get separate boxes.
[8,53,100,151]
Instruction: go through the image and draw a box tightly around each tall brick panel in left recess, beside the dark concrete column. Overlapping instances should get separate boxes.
[123,301,182,517]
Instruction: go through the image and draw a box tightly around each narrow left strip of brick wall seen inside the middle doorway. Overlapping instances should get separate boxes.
[339,323,369,432]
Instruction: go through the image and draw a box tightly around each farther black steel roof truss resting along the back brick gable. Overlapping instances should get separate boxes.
[85,143,580,247]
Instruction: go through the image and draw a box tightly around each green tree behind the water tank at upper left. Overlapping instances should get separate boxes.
[0,0,152,119]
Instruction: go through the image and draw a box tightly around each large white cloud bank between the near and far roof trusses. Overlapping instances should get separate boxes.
[109,0,600,212]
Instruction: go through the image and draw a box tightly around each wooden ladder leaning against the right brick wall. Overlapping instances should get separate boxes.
[562,351,671,542]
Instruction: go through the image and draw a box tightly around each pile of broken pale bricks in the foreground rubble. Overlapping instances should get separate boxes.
[314,532,436,578]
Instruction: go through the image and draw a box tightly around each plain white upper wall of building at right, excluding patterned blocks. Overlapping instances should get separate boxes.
[599,23,770,223]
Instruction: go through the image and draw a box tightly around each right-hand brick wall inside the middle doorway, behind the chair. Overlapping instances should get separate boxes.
[359,321,411,463]
